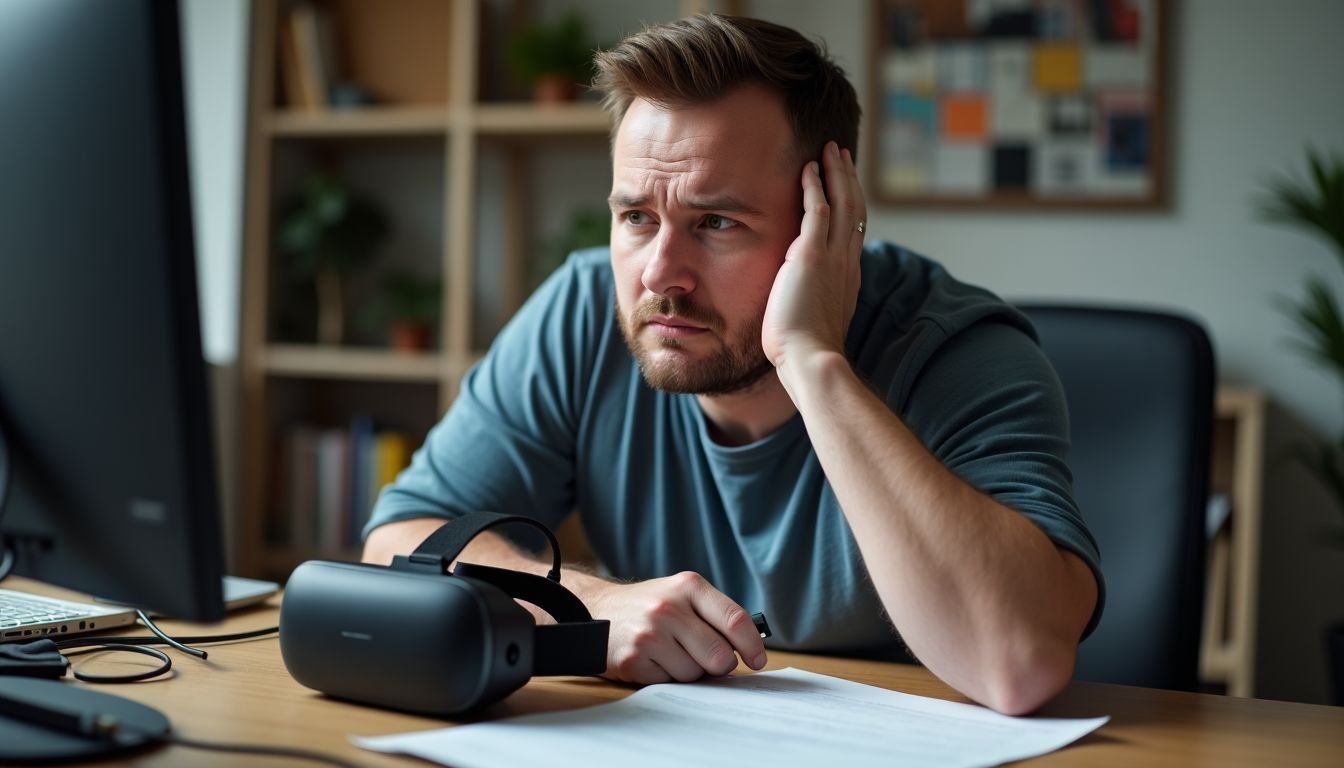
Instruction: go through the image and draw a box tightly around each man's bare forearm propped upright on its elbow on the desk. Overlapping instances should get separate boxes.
[781,355,1095,714]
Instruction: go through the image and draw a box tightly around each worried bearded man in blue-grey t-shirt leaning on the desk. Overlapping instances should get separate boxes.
[364,16,1099,714]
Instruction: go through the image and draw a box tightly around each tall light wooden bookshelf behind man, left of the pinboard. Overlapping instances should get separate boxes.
[235,0,741,581]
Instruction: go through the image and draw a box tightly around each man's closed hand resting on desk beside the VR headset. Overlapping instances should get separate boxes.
[586,572,766,685]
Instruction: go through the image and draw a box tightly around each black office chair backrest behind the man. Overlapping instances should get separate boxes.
[1020,305,1214,690]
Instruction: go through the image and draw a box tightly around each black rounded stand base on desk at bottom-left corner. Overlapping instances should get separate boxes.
[0,675,169,764]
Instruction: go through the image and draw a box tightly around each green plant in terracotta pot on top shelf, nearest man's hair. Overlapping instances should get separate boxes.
[505,11,594,104]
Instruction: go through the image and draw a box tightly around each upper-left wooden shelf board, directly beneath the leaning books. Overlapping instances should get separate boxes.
[266,106,452,139]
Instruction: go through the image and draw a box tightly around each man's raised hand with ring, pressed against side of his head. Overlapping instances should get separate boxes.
[761,141,868,386]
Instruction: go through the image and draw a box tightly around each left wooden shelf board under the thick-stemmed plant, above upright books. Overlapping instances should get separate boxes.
[261,344,446,383]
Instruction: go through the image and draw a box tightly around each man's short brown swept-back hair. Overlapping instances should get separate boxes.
[593,13,860,160]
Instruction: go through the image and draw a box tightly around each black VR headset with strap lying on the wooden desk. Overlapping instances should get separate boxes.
[280,512,610,716]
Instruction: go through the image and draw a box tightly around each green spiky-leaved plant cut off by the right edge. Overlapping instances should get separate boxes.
[1261,148,1344,705]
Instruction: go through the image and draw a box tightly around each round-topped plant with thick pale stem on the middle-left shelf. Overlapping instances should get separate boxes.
[277,172,387,344]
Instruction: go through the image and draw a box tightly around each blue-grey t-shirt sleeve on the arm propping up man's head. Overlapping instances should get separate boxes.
[902,321,1105,636]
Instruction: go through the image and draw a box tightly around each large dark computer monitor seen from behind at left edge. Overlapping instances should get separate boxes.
[0,0,224,621]
